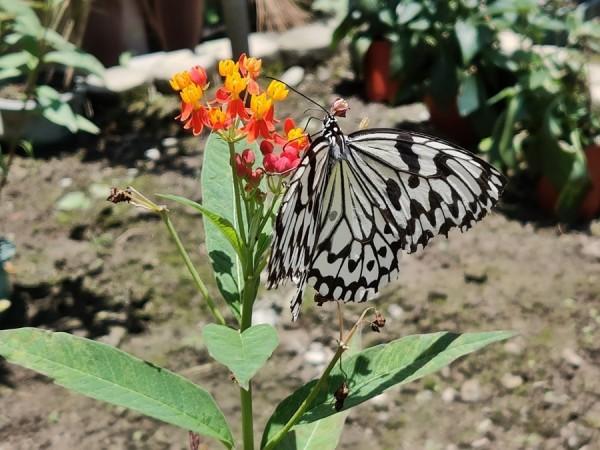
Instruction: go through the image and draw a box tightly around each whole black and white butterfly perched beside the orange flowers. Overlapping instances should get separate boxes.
[268,102,506,320]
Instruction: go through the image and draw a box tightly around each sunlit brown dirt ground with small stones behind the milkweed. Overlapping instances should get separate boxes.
[0,53,600,450]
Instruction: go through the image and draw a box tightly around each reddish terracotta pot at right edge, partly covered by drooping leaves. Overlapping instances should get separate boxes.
[536,145,600,220]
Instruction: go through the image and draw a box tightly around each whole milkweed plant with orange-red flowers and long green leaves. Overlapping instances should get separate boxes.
[0,55,512,450]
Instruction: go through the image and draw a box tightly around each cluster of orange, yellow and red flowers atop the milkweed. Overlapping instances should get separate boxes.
[170,55,309,179]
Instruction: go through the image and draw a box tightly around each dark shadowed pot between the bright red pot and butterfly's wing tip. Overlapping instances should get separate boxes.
[423,94,476,145]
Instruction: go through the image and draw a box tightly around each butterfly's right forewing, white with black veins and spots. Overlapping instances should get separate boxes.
[348,129,505,252]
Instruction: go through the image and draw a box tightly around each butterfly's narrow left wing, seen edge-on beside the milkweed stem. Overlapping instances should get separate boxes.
[267,138,329,289]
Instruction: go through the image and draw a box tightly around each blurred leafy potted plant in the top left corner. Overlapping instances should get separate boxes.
[0,0,103,189]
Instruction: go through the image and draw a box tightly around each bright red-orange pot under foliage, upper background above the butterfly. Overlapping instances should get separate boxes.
[363,40,400,102]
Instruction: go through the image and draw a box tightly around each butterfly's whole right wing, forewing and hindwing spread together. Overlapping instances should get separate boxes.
[308,129,505,301]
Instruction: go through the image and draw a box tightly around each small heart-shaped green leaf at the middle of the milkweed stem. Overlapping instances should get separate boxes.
[202,323,279,390]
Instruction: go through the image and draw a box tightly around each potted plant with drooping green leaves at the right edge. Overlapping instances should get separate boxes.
[480,8,600,220]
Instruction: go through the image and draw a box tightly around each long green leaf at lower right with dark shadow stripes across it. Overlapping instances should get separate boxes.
[263,331,514,442]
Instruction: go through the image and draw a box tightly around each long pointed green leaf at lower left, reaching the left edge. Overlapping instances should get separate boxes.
[0,328,233,448]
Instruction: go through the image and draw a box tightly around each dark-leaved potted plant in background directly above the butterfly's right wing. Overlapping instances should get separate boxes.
[333,0,511,143]
